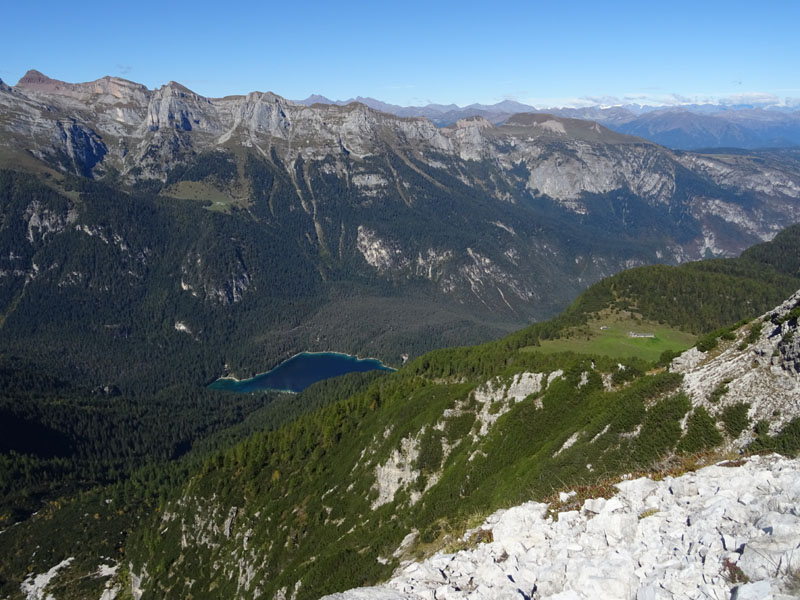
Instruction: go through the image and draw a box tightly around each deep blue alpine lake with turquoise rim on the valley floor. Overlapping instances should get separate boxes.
[208,352,395,393]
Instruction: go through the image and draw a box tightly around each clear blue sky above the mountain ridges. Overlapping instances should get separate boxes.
[0,0,800,106]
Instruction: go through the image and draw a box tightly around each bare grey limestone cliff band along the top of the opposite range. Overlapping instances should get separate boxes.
[0,71,800,255]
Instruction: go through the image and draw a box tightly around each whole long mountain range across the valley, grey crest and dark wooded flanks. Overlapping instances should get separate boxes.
[0,71,800,385]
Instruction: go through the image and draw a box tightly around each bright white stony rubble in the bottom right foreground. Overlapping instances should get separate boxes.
[327,455,800,600]
